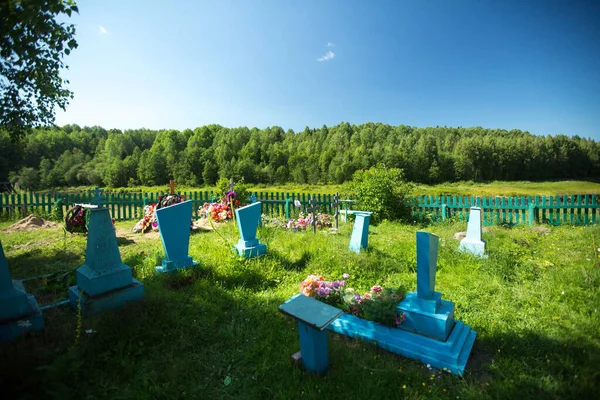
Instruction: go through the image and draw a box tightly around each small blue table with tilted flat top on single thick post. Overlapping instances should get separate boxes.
[279,294,343,374]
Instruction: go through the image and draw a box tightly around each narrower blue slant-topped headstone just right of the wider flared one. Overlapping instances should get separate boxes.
[233,201,267,258]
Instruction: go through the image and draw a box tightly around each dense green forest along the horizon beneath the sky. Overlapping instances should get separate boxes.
[0,123,600,190]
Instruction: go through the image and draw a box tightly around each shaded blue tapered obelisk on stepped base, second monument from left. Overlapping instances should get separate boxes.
[69,207,144,315]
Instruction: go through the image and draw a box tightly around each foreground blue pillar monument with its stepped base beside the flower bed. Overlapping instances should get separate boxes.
[327,232,477,376]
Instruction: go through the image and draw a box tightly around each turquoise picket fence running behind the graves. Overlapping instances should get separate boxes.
[0,191,600,225]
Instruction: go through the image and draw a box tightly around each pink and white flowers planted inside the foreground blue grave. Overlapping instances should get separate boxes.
[300,274,406,327]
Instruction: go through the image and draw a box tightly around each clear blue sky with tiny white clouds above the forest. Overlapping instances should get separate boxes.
[56,0,600,140]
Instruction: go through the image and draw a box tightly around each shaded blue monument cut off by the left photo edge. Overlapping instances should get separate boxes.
[0,242,44,340]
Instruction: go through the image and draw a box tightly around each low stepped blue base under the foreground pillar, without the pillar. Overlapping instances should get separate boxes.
[327,314,477,376]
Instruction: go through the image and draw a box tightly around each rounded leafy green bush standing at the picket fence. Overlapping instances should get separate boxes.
[346,166,413,223]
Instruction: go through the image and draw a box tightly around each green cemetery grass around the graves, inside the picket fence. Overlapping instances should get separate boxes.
[0,222,600,399]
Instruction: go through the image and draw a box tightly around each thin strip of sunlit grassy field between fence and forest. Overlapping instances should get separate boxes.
[34,181,600,196]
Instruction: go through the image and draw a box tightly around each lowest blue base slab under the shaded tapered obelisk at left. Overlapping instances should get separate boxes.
[69,279,144,316]
